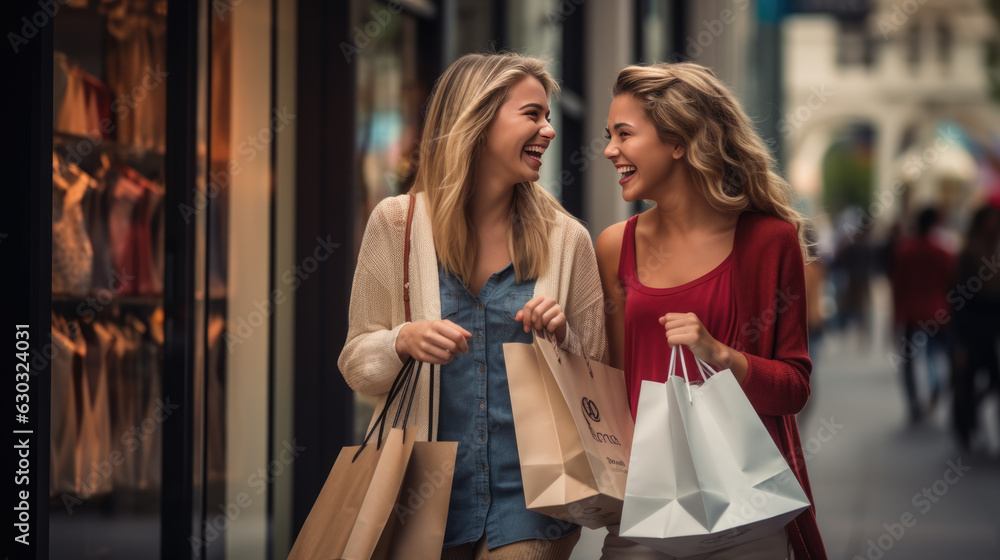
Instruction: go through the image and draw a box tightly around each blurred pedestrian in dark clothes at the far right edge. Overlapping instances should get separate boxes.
[952,206,1000,449]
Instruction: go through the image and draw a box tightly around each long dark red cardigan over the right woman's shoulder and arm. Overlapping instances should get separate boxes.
[733,212,826,560]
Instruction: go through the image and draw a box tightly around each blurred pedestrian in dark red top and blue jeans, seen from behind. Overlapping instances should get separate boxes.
[889,208,955,424]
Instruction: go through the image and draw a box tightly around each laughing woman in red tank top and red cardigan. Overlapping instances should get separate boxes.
[597,63,826,560]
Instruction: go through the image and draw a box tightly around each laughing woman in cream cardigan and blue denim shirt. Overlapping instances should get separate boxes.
[338,53,607,559]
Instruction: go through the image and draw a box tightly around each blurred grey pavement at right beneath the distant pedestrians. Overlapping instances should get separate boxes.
[572,330,1000,560]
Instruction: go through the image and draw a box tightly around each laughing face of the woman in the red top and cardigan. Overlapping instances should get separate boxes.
[604,94,684,202]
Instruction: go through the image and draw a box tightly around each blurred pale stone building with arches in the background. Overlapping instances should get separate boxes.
[781,0,1000,238]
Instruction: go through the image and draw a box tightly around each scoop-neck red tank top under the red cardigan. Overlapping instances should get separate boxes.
[618,215,737,420]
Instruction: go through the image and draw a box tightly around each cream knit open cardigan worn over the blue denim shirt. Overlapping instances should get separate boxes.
[337,193,608,441]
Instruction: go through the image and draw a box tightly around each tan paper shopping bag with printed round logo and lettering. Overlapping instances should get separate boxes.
[503,335,634,529]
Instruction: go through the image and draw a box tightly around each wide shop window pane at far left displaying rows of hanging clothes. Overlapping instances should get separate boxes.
[49,0,168,559]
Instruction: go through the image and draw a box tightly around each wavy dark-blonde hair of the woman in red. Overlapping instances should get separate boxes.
[612,62,809,261]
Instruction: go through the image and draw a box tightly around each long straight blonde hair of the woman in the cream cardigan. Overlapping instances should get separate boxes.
[412,52,565,284]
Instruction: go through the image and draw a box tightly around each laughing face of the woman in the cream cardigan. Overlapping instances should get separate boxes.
[480,76,556,185]
